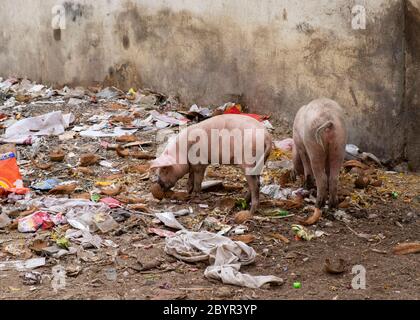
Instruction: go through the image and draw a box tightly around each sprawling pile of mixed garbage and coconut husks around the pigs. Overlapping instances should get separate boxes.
[0,78,420,296]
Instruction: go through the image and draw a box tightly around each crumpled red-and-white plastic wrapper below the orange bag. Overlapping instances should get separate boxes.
[18,211,67,233]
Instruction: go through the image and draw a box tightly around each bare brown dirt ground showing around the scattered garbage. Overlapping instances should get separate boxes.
[0,85,420,300]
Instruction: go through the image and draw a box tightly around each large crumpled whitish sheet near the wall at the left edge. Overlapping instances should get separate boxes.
[0,111,74,144]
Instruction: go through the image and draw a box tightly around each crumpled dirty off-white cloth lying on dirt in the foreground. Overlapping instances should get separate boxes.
[165,230,283,289]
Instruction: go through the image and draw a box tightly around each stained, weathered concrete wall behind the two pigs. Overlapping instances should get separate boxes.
[0,0,420,169]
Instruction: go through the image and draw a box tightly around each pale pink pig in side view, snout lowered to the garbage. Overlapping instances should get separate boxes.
[151,114,272,213]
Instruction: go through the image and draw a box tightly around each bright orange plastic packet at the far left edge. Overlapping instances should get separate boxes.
[0,152,27,194]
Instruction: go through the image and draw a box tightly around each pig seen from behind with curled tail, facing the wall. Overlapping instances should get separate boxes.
[293,98,347,208]
